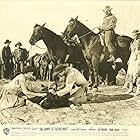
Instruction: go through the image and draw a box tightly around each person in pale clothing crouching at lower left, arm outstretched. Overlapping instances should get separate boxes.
[0,66,46,110]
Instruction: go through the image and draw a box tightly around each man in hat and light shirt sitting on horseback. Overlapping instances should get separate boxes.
[99,6,118,62]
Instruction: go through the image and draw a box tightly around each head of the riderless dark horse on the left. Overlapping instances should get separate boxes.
[29,24,45,45]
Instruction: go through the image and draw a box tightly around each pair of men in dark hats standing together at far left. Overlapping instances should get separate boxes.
[1,39,25,79]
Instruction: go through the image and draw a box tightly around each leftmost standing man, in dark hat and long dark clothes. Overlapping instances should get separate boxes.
[2,39,13,79]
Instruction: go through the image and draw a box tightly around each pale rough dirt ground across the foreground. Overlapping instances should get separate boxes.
[0,74,140,125]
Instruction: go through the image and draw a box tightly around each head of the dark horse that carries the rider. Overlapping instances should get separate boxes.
[63,16,79,38]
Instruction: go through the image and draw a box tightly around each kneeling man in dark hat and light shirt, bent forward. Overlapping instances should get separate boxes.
[42,64,89,105]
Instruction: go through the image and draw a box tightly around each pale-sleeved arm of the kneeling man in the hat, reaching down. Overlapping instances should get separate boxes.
[56,73,75,96]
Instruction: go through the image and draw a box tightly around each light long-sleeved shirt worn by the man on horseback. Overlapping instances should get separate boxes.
[102,14,117,31]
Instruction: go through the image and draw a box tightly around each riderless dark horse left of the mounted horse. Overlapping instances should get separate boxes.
[29,24,89,79]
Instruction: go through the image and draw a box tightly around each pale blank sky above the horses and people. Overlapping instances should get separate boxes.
[0,0,140,55]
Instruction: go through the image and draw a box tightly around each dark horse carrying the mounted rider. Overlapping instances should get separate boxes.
[64,17,132,87]
